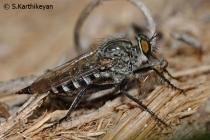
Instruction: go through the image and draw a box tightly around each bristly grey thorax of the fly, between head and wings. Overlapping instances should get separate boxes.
[97,39,147,77]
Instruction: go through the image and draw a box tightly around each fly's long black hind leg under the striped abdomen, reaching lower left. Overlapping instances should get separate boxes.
[43,84,115,131]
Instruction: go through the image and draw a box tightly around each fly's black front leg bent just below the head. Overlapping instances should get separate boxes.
[134,66,185,93]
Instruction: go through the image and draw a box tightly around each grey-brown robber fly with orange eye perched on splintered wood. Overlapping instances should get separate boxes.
[17,34,183,128]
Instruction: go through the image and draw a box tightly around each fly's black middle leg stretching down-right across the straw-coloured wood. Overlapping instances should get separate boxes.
[120,77,168,127]
